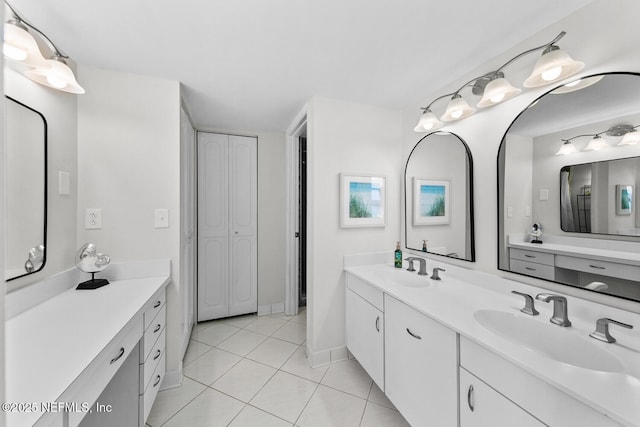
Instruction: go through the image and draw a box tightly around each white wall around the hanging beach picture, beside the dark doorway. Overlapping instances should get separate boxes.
[307,97,404,364]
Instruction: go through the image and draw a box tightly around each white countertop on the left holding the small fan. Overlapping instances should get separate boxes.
[6,276,169,426]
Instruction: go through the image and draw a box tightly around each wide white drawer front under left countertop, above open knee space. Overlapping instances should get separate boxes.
[59,316,142,426]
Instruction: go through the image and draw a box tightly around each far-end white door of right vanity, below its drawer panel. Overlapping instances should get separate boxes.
[346,289,384,391]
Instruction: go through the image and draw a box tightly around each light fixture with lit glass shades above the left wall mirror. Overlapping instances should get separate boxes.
[3,1,85,94]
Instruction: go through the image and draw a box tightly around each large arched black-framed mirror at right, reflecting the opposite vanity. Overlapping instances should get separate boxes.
[498,73,640,301]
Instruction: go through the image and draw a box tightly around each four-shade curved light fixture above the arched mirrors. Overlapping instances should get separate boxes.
[413,31,584,132]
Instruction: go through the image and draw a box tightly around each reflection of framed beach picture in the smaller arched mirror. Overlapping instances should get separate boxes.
[413,177,451,225]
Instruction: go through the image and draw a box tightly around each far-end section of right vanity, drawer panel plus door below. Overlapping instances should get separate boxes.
[346,277,384,391]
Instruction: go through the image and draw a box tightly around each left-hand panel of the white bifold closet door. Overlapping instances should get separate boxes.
[198,133,229,321]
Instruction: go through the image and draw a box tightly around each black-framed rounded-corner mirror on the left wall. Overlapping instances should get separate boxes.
[5,97,47,280]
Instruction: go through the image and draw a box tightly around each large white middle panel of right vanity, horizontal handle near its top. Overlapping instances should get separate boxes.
[384,295,458,427]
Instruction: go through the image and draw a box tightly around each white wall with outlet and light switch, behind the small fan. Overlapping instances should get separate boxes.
[77,66,182,382]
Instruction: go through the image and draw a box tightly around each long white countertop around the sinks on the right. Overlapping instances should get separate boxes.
[345,260,640,426]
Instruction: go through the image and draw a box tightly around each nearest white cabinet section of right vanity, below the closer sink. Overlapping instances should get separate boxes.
[460,336,620,427]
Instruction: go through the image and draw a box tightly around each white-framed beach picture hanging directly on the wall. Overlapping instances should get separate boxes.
[340,174,386,228]
